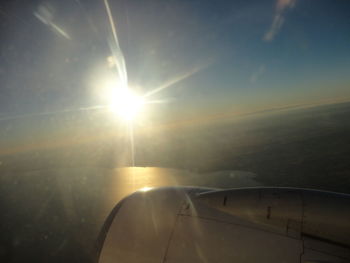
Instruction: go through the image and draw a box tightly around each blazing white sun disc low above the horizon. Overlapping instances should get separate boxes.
[109,88,145,122]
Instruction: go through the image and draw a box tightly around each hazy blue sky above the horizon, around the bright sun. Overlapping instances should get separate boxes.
[0,0,350,124]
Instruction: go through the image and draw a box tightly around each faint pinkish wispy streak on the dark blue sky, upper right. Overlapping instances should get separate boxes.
[263,0,296,42]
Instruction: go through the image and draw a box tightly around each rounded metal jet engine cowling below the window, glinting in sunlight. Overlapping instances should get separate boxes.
[97,187,350,263]
